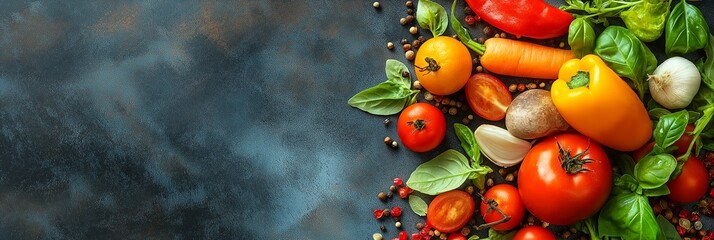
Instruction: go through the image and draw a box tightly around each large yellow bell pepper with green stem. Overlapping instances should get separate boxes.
[550,55,652,151]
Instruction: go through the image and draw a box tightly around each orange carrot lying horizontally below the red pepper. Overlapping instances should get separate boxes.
[474,38,575,79]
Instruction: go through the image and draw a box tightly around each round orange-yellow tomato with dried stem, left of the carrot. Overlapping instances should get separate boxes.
[414,36,473,95]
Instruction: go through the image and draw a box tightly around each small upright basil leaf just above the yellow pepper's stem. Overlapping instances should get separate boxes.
[568,18,595,58]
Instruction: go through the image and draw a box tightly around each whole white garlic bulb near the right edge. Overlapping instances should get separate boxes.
[647,57,702,109]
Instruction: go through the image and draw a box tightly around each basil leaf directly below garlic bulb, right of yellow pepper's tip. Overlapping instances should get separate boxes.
[652,110,689,149]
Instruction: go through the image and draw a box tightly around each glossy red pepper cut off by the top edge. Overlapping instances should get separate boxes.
[466,0,573,39]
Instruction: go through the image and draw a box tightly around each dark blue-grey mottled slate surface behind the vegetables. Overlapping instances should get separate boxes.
[0,0,714,239]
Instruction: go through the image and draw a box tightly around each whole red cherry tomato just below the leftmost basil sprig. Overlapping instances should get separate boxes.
[397,103,446,152]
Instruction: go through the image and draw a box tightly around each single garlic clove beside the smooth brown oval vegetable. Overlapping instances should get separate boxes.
[474,124,531,167]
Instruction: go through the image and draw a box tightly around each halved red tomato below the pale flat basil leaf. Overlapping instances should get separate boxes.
[426,190,476,233]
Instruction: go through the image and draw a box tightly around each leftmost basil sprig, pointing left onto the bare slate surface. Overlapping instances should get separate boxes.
[347,59,419,115]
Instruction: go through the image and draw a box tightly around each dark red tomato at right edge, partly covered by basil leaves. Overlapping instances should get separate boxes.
[667,156,709,203]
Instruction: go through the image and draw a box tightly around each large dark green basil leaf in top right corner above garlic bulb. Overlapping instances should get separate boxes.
[665,1,709,56]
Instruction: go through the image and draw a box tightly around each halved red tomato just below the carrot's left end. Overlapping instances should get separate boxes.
[464,73,513,121]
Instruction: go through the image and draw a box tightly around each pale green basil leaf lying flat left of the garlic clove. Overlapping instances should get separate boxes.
[407,149,478,195]
